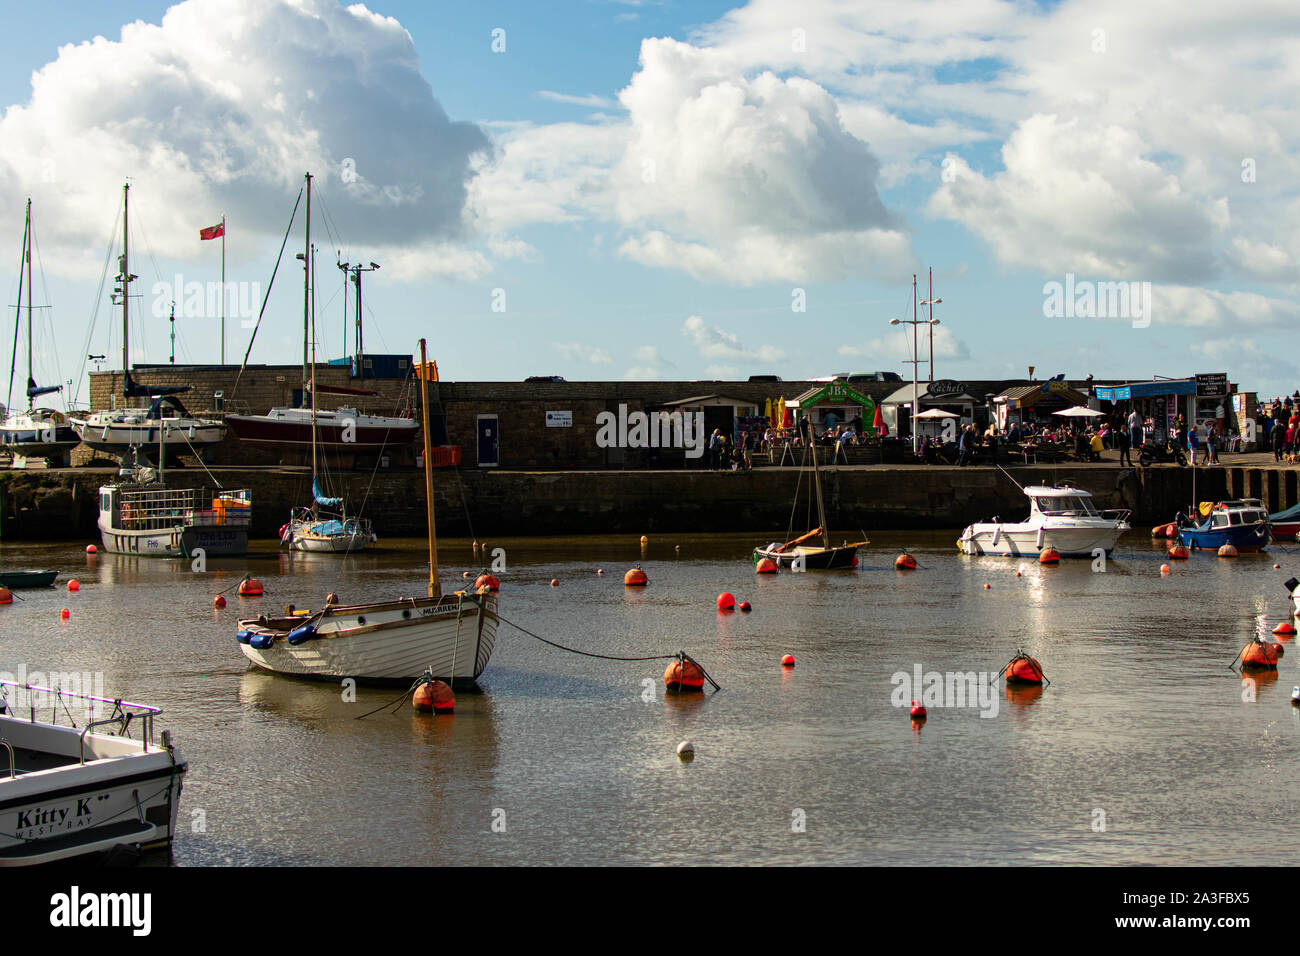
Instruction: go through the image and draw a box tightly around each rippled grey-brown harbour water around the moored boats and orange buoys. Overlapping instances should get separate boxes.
[0,531,1300,866]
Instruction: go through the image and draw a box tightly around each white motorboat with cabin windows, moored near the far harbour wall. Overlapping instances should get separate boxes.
[957,485,1128,558]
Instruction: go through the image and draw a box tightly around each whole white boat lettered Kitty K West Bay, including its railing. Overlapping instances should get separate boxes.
[0,680,186,866]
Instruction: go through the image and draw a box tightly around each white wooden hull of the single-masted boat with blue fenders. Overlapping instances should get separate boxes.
[239,593,498,687]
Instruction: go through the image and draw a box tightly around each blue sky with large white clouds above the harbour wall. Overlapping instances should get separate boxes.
[0,0,1300,408]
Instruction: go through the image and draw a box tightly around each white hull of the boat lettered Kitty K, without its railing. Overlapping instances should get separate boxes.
[0,715,186,866]
